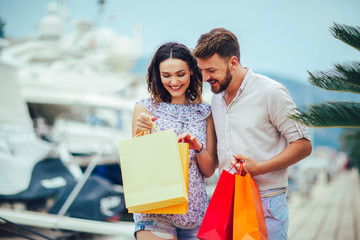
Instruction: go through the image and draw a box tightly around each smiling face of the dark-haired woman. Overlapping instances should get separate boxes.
[159,58,191,104]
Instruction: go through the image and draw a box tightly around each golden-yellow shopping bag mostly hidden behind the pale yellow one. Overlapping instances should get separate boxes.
[142,143,189,214]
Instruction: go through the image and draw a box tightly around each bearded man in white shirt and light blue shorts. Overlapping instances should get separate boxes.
[193,28,312,240]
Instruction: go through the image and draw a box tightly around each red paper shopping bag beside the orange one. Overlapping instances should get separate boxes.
[197,170,235,240]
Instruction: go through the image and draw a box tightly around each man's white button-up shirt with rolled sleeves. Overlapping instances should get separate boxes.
[211,69,310,191]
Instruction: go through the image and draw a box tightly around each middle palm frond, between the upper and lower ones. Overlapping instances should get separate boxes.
[308,62,360,93]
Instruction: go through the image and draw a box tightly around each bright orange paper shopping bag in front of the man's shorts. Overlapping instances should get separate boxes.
[233,165,267,240]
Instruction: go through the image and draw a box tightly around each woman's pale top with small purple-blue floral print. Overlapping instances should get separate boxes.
[134,98,211,228]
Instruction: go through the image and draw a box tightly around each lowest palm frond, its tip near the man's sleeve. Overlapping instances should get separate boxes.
[289,102,360,128]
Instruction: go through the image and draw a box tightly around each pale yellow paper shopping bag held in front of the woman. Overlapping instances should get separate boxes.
[119,130,188,213]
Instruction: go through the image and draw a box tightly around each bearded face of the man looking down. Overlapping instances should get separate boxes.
[197,53,232,94]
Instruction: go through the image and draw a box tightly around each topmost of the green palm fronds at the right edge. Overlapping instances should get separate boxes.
[330,23,360,51]
